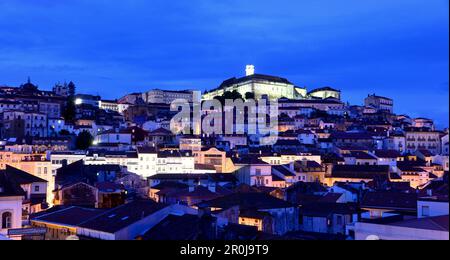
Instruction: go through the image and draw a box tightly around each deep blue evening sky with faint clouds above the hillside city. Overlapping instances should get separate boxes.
[0,0,449,127]
